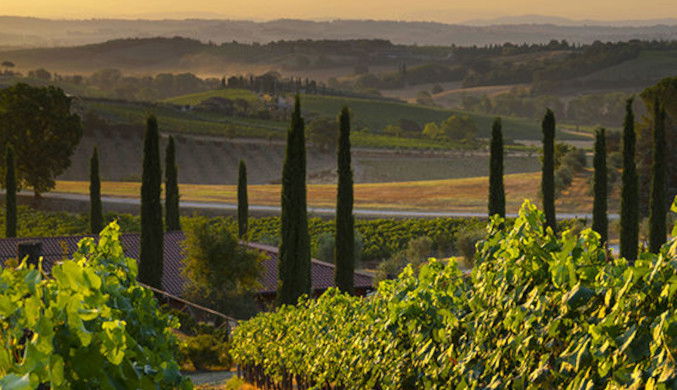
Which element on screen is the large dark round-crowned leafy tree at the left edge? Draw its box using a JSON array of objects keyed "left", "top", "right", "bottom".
[{"left": 0, "top": 83, "right": 82, "bottom": 196}]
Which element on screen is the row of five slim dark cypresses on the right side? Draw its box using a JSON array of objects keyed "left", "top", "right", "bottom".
[{"left": 488, "top": 98, "right": 668, "bottom": 261}]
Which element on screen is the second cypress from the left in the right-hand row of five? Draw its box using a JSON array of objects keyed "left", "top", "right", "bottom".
[{"left": 541, "top": 109, "right": 557, "bottom": 232}]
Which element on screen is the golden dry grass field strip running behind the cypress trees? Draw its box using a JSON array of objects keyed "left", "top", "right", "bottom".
[{"left": 54, "top": 173, "right": 614, "bottom": 213}]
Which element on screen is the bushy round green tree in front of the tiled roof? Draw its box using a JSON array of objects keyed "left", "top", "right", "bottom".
[{"left": 182, "top": 217, "right": 265, "bottom": 312}]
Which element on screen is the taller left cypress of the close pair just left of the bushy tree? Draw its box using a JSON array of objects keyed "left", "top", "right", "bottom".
[{"left": 139, "top": 115, "right": 164, "bottom": 288}]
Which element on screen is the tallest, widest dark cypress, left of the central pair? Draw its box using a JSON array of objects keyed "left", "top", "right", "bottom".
[{"left": 277, "top": 95, "right": 311, "bottom": 304}]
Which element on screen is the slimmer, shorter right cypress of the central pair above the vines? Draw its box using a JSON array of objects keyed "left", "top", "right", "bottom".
[{"left": 334, "top": 107, "right": 355, "bottom": 294}]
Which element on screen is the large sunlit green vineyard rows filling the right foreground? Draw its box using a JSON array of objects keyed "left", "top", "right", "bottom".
[{"left": 231, "top": 202, "right": 677, "bottom": 389}]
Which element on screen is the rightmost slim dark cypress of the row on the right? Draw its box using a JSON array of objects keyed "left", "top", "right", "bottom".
[{"left": 649, "top": 99, "right": 667, "bottom": 253}]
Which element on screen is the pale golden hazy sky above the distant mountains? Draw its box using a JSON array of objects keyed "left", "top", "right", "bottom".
[{"left": 0, "top": 0, "right": 677, "bottom": 22}]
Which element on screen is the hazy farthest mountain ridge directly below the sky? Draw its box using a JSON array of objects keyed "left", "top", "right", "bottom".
[{"left": 0, "top": 16, "right": 677, "bottom": 47}]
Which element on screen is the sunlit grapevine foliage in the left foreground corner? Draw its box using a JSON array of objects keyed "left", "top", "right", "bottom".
[{"left": 0, "top": 224, "right": 191, "bottom": 390}]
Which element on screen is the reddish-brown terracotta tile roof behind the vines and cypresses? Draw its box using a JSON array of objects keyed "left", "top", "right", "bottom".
[{"left": 0, "top": 232, "right": 373, "bottom": 296}]
